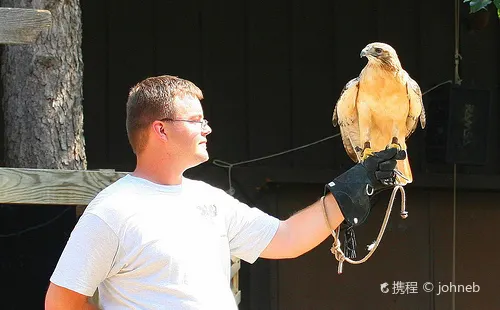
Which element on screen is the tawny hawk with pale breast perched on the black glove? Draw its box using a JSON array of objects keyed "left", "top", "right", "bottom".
[{"left": 332, "top": 42, "right": 425, "bottom": 185}]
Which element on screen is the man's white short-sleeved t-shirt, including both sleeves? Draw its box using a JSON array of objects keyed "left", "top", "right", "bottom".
[{"left": 50, "top": 175, "right": 279, "bottom": 310}]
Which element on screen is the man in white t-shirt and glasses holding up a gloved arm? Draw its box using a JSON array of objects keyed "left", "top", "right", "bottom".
[{"left": 45, "top": 76, "right": 397, "bottom": 309}]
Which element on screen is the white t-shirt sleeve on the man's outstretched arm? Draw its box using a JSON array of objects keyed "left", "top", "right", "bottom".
[{"left": 224, "top": 193, "right": 280, "bottom": 263}]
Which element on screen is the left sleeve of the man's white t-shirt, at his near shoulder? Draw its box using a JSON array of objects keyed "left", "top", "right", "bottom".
[{"left": 50, "top": 213, "right": 118, "bottom": 296}]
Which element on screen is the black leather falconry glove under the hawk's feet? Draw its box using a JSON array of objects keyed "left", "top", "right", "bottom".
[{"left": 326, "top": 148, "right": 406, "bottom": 257}]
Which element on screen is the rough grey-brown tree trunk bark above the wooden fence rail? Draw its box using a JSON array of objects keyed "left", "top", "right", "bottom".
[{"left": 2, "top": 0, "right": 87, "bottom": 169}]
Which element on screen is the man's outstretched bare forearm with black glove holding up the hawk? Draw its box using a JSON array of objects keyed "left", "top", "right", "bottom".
[{"left": 260, "top": 148, "right": 406, "bottom": 259}]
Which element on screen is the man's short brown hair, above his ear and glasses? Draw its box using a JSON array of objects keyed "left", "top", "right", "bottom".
[{"left": 127, "top": 75, "right": 203, "bottom": 154}]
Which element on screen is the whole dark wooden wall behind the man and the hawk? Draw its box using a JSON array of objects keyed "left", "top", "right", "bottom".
[{"left": 82, "top": 0, "right": 500, "bottom": 310}]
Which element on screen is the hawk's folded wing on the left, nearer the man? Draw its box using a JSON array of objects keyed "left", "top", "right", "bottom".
[{"left": 332, "top": 78, "right": 361, "bottom": 162}]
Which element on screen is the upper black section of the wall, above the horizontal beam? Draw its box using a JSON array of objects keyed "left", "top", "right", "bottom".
[{"left": 76, "top": 0, "right": 499, "bottom": 177}]
